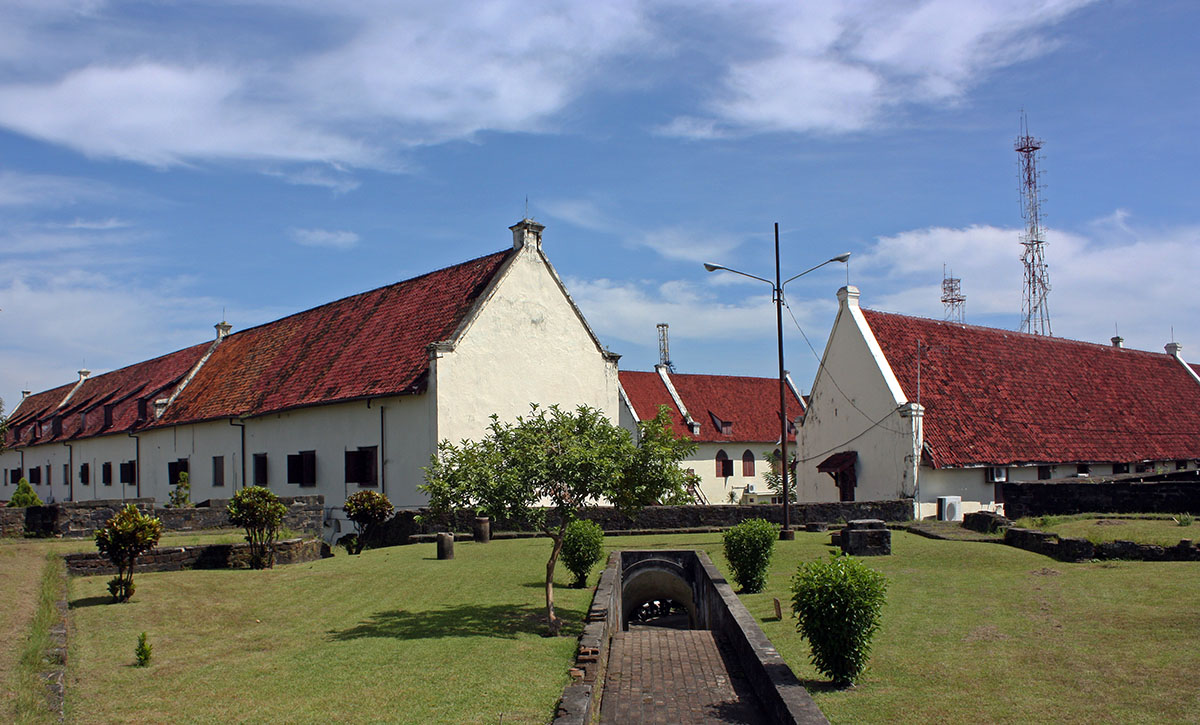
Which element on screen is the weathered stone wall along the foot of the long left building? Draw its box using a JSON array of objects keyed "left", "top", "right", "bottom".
[{"left": 0, "top": 496, "right": 325, "bottom": 538}]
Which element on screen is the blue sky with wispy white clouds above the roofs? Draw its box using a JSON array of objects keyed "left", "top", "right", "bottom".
[{"left": 0, "top": 0, "right": 1200, "bottom": 411}]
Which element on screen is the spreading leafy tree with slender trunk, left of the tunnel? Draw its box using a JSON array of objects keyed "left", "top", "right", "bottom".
[{"left": 421, "top": 405, "right": 695, "bottom": 635}]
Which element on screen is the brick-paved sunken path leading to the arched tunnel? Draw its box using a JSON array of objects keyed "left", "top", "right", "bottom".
[{"left": 600, "top": 627, "right": 767, "bottom": 725}]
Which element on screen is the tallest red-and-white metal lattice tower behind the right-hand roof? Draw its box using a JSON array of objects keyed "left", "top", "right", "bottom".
[{"left": 1013, "top": 113, "right": 1054, "bottom": 335}]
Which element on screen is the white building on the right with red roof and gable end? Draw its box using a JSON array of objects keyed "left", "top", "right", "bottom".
[{"left": 797, "top": 287, "right": 1200, "bottom": 517}]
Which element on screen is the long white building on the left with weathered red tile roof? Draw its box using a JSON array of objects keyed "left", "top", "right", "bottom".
[{"left": 0, "top": 220, "right": 618, "bottom": 535}]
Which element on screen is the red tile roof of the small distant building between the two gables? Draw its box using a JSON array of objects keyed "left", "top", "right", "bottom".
[{"left": 619, "top": 370, "right": 803, "bottom": 443}]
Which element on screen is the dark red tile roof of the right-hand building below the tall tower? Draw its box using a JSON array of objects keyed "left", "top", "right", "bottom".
[{"left": 863, "top": 310, "right": 1200, "bottom": 468}]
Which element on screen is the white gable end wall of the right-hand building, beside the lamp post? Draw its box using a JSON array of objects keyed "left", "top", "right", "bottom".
[{"left": 797, "top": 287, "right": 922, "bottom": 502}]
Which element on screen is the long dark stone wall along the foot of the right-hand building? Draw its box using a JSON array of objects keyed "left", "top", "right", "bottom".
[{"left": 1003, "top": 479, "right": 1200, "bottom": 519}]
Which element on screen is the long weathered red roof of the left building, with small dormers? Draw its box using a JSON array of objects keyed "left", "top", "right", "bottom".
[{"left": 10, "top": 250, "right": 512, "bottom": 445}]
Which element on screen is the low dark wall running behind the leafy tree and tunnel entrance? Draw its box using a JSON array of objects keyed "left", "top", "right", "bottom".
[{"left": 372, "top": 498, "right": 912, "bottom": 546}]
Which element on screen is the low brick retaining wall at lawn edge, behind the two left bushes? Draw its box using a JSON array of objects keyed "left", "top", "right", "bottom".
[{"left": 62, "top": 539, "right": 332, "bottom": 576}]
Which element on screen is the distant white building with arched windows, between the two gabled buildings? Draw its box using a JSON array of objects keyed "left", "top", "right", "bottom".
[{"left": 620, "top": 365, "right": 804, "bottom": 504}]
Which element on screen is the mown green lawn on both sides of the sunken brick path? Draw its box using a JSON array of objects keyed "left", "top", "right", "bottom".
[{"left": 16, "top": 532, "right": 1200, "bottom": 723}]
